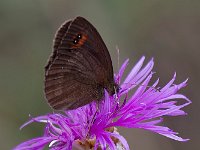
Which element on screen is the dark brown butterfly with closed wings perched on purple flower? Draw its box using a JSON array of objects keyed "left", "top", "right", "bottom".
[{"left": 45, "top": 17, "right": 118, "bottom": 110}]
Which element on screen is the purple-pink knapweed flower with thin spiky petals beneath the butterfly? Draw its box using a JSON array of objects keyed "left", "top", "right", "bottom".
[{"left": 14, "top": 57, "right": 191, "bottom": 150}]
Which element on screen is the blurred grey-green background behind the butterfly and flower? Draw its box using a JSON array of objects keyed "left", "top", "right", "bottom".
[{"left": 0, "top": 0, "right": 200, "bottom": 150}]
